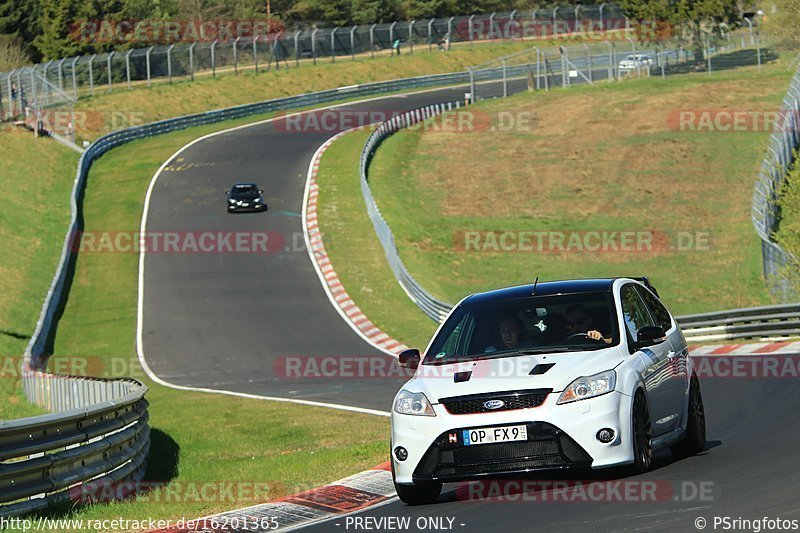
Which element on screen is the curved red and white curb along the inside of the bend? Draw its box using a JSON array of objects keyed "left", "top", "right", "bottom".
[{"left": 303, "top": 128, "right": 408, "bottom": 355}]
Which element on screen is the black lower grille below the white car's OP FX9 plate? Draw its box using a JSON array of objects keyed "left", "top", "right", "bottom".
[{"left": 414, "top": 422, "right": 592, "bottom": 481}]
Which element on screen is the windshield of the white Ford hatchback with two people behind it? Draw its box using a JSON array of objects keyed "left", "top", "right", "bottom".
[{"left": 424, "top": 291, "right": 619, "bottom": 365}]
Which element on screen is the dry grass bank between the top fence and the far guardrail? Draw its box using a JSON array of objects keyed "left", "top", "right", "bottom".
[{"left": 75, "top": 41, "right": 540, "bottom": 139}]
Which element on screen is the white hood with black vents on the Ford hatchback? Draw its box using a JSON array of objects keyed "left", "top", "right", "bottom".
[{"left": 404, "top": 346, "right": 627, "bottom": 403}]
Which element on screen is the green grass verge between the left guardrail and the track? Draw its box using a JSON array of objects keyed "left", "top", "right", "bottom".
[{"left": 7, "top": 117, "right": 387, "bottom": 519}]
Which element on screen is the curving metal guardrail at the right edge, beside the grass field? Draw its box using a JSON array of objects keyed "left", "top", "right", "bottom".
[{"left": 752, "top": 61, "right": 800, "bottom": 300}]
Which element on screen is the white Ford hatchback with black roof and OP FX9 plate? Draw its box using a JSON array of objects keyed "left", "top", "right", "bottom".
[{"left": 391, "top": 278, "right": 705, "bottom": 504}]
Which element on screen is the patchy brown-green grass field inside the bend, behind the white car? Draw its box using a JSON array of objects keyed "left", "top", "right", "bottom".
[{"left": 310, "top": 61, "right": 791, "bottom": 346}]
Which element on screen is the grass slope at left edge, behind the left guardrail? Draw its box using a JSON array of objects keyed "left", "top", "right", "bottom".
[{"left": 0, "top": 127, "right": 78, "bottom": 419}]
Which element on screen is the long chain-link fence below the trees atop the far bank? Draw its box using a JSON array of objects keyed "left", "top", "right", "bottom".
[{"left": 0, "top": 3, "right": 648, "bottom": 119}]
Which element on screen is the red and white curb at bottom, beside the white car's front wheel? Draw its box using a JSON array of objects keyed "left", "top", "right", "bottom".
[{"left": 150, "top": 461, "right": 395, "bottom": 533}]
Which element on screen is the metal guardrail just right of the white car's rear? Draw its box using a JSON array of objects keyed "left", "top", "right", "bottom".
[{"left": 676, "top": 303, "right": 800, "bottom": 342}]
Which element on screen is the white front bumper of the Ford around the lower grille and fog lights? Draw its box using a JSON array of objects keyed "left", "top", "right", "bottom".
[{"left": 391, "top": 391, "right": 633, "bottom": 483}]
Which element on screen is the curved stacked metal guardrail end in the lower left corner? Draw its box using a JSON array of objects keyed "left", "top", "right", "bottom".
[{"left": 0, "top": 370, "right": 150, "bottom": 517}]
